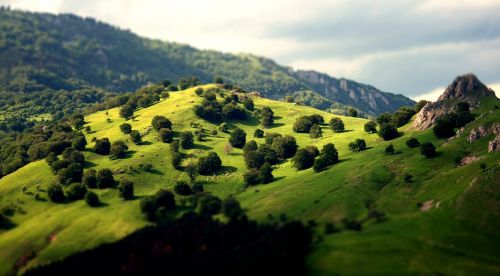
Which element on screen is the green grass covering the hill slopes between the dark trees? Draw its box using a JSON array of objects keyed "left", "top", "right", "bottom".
[{"left": 0, "top": 85, "right": 500, "bottom": 275}]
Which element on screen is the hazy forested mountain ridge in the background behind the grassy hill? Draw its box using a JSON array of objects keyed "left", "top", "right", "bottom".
[{"left": 0, "top": 8, "right": 414, "bottom": 114}]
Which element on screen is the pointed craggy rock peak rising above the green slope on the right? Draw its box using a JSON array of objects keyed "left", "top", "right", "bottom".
[{"left": 413, "top": 74, "right": 496, "bottom": 130}]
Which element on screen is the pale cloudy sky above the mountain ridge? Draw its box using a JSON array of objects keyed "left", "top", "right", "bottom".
[{"left": 0, "top": 0, "right": 500, "bottom": 100}]
